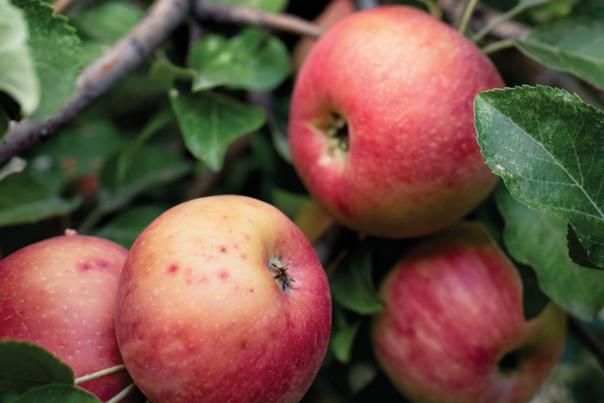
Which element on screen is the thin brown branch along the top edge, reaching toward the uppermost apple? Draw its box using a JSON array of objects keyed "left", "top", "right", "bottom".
[{"left": 193, "top": 0, "right": 323, "bottom": 38}]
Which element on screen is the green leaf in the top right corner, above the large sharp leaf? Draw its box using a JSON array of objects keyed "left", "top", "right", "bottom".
[{"left": 518, "top": 0, "right": 604, "bottom": 89}]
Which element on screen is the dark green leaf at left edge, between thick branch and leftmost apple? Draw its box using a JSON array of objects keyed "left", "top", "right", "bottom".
[{"left": 0, "top": 171, "right": 80, "bottom": 226}]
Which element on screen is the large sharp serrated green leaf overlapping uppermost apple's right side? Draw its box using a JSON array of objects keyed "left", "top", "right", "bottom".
[{"left": 474, "top": 86, "right": 604, "bottom": 267}]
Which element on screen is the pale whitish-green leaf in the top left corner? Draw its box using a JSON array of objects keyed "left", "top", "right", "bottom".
[{"left": 0, "top": 0, "right": 40, "bottom": 118}]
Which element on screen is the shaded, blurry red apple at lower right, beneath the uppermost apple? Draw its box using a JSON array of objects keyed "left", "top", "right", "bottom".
[{"left": 372, "top": 223, "right": 566, "bottom": 403}]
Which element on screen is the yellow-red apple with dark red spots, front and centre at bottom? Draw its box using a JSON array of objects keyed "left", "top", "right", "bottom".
[{"left": 116, "top": 196, "right": 331, "bottom": 403}]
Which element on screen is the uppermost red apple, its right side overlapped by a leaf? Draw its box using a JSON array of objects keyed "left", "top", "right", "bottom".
[{"left": 289, "top": 6, "right": 503, "bottom": 238}]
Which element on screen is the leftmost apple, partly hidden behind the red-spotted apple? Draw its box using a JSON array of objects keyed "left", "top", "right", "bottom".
[{"left": 0, "top": 234, "right": 132, "bottom": 401}]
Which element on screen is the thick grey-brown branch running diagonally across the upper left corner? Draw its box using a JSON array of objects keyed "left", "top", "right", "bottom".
[{"left": 0, "top": 0, "right": 189, "bottom": 164}]
